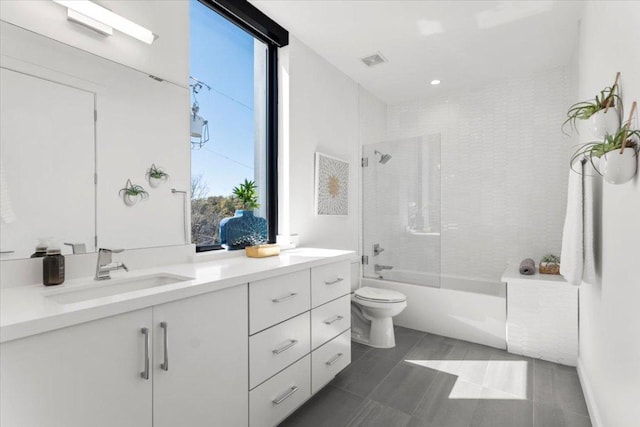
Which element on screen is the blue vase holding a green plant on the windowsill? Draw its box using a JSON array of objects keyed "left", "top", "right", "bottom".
[{"left": 220, "top": 179, "right": 267, "bottom": 250}]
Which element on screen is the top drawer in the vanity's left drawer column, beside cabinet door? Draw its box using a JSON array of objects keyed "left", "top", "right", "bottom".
[{"left": 249, "top": 269, "right": 311, "bottom": 335}]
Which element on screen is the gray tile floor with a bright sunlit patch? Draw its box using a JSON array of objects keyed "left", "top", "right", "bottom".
[{"left": 280, "top": 327, "right": 591, "bottom": 427}]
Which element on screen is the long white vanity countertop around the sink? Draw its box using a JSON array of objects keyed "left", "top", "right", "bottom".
[{"left": 0, "top": 248, "right": 355, "bottom": 342}]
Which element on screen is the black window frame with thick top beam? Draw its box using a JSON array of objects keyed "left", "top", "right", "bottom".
[{"left": 198, "top": 0, "right": 289, "bottom": 243}]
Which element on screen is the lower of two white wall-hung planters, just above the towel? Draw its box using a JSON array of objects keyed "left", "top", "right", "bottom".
[{"left": 571, "top": 102, "right": 640, "bottom": 184}]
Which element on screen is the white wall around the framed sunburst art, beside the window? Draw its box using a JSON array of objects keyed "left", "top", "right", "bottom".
[{"left": 279, "top": 37, "right": 384, "bottom": 251}]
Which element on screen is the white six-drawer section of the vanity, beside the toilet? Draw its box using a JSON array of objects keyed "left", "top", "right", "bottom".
[{"left": 249, "top": 261, "right": 351, "bottom": 427}]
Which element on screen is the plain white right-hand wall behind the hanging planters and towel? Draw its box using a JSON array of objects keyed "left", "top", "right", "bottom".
[{"left": 578, "top": 1, "right": 640, "bottom": 427}]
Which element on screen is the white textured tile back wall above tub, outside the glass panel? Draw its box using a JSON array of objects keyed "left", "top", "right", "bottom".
[{"left": 387, "top": 67, "right": 577, "bottom": 282}]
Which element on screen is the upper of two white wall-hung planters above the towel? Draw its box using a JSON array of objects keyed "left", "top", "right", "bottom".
[{"left": 562, "top": 73, "right": 620, "bottom": 139}]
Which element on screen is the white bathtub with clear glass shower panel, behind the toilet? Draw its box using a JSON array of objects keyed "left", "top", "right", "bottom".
[{"left": 360, "top": 134, "right": 506, "bottom": 348}]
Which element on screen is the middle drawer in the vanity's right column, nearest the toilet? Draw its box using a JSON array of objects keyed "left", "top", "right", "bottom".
[{"left": 311, "top": 295, "right": 351, "bottom": 349}]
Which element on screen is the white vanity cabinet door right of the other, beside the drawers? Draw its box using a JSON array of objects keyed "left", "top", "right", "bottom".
[{"left": 153, "top": 285, "right": 249, "bottom": 427}]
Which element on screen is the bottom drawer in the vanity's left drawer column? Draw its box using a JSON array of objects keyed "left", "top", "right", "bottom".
[{"left": 249, "top": 355, "right": 311, "bottom": 427}]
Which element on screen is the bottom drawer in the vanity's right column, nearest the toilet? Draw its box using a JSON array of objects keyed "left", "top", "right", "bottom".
[{"left": 311, "top": 330, "right": 351, "bottom": 394}]
